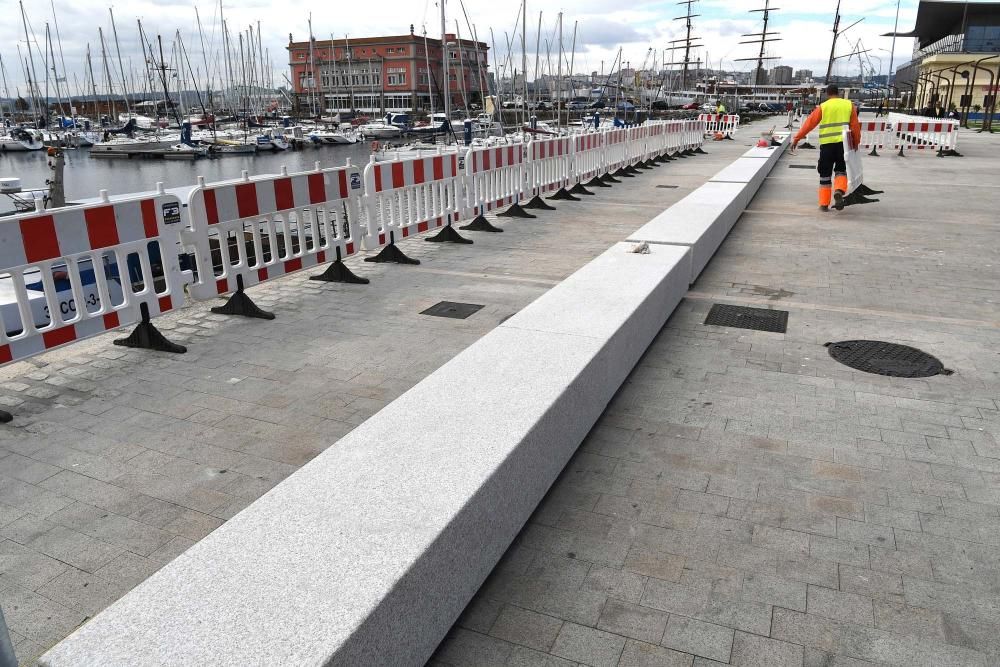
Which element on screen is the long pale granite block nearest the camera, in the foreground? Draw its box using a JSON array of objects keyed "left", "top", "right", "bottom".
[{"left": 41, "top": 243, "right": 696, "bottom": 667}]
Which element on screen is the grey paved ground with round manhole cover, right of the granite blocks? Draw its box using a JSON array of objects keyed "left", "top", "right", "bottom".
[{"left": 431, "top": 122, "right": 1000, "bottom": 667}]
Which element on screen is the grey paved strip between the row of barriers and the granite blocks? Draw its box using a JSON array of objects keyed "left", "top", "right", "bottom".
[{"left": 0, "top": 128, "right": 764, "bottom": 664}]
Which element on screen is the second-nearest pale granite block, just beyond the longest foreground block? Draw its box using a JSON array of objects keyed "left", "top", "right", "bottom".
[{"left": 628, "top": 183, "right": 749, "bottom": 283}]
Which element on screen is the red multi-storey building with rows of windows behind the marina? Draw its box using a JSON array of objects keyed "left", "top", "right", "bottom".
[{"left": 288, "top": 32, "right": 491, "bottom": 115}]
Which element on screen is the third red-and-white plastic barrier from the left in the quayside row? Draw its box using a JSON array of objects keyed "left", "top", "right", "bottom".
[{"left": 364, "top": 153, "right": 464, "bottom": 245}]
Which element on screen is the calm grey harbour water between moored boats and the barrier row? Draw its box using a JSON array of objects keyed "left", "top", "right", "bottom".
[{"left": 0, "top": 142, "right": 371, "bottom": 211}]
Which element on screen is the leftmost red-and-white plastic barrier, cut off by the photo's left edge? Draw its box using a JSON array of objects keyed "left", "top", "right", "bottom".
[{"left": 0, "top": 189, "right": 185, "bottom": 364}]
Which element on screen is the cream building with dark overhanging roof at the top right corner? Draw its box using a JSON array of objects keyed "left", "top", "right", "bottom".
[{"left": 895, "top": 0, "right": 1000, "bottom": 117}]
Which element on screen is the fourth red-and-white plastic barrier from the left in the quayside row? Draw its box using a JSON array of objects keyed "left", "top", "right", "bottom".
[{"left": 464, "top": 144, "right": 525, "bottom": 217}]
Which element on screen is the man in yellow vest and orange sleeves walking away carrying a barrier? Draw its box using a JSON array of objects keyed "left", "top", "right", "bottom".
[{"left": 792, "top": 84, "right": 861, "bottom": 211}]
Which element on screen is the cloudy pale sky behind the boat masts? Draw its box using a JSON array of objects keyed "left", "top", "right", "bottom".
[{"left": 0, "top": 0, "right": 917, "bottom": 95}]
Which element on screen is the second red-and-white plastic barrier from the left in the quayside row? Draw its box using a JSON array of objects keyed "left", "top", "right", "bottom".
[{"left": 182, "top": 163, "right": 361, "bottom": 299}]
